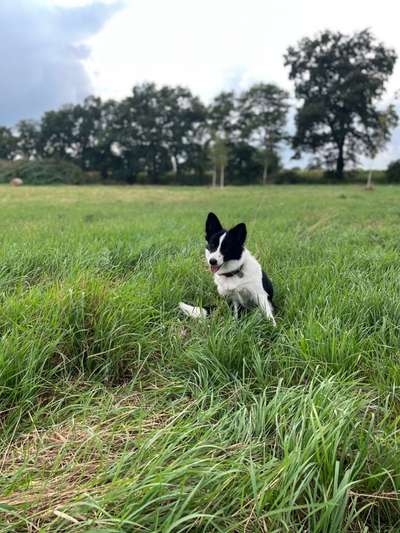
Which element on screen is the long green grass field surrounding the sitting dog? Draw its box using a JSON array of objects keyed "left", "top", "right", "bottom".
[{"left": 0, "top": 186, "right": 400, "bottom": 533}]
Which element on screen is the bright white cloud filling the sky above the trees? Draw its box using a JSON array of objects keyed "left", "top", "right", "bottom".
[{"left": 88, "top": 0, "right": 400, "bottom": 98}]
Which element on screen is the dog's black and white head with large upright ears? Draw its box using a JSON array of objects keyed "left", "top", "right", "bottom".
[{"left": 206, "top": 213, "right": 247, "bottom": 274}]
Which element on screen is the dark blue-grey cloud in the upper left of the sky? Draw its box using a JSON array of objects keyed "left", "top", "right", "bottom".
[{"left": 0, "top": 0, "right": 122, "bottom": 125}]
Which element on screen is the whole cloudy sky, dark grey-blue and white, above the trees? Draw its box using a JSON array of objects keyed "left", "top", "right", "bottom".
[{"left": 0, "top": 0, "right": 400, "bottom": 168}]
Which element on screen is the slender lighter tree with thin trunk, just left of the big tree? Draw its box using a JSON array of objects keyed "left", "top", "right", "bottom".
[{"left": 239, "top": 83, "right": 289, "bottom": 184}]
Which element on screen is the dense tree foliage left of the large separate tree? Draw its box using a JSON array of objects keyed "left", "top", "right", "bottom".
[{"left": 1, "top": 83, "right": 287, "bottom": 185}]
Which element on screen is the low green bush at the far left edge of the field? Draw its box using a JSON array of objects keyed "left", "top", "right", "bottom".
[{"left": 0, "top": 159, "right": 86, "bottom": 185}]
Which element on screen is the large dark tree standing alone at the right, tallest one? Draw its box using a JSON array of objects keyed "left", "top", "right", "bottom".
[{"left": 285, "top": 30, "right": 397, "bottom": 178}]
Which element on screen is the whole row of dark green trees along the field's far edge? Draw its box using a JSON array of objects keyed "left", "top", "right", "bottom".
[{"left": 0, "top": 30, "right": 398, "bottom": 186}]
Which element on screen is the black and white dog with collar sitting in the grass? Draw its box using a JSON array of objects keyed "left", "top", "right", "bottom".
[{"left": 179, "top": 213, "right": 276, "bottom": 326}]
